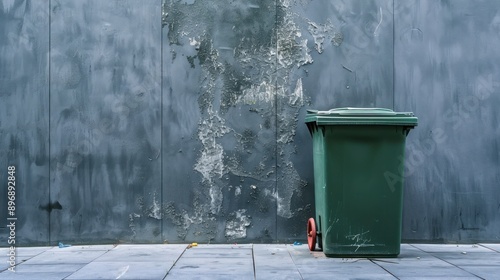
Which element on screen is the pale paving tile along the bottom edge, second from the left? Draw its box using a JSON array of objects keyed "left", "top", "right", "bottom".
[{"left": 65, "top": 261, "right": 171, "bottom": 280}]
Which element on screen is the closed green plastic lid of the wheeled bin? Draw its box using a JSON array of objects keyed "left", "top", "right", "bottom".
[{"left": 306, "top": 107, "right": 418, "bottom": 126}]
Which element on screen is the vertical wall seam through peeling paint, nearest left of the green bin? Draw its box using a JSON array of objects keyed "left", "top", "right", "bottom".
[{"left": 274, "top": 0, "right": 279, "bottom": 241}]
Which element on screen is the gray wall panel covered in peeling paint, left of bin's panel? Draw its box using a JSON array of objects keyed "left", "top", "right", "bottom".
[{"left": 163, "top": 0, "right": 276, "bottom": 242}]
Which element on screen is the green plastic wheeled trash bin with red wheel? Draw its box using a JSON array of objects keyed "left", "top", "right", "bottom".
[{"left": 305, "top": 108, "right": 418, "bottom": 257}]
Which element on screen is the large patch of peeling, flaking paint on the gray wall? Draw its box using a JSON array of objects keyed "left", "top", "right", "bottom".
[{"left": 163, "top": 1, "right": 313, "bottom": 241}]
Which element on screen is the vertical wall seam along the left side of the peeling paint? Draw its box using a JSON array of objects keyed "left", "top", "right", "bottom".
[{"left": 159, "top": 0, "right": 165, "bottom": 243}]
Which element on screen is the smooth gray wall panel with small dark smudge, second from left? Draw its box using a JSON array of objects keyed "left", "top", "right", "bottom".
[{"left": 50, "top": 1, "right": 161, "bottom": 242}]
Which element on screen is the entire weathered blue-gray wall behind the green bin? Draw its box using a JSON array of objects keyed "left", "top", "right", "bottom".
[{"left": 0, "top": 0, "right": 500, "bottom": 246}]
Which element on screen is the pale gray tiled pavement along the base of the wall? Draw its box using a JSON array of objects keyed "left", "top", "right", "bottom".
[{"left": 0, "top": 244, "right": 500, "bottom": 280}]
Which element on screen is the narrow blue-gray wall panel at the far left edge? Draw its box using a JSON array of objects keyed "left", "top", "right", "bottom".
[{"left": 0, "top": 1, "right": 49, "bottom": 246}]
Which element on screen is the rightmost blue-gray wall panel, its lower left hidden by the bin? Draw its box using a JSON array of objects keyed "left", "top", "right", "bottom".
[{"left": 395, "top": 0, "right": 500, "bottom": 242}]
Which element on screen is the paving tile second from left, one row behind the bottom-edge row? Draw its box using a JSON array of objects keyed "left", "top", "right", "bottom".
[{"left": 24, "top": 251, "right": 106, "bottom": 264}]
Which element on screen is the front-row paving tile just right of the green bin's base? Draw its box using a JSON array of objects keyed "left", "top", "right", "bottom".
[{"left": 375, "top": 259, "right": 474, "bottom": 278}]
